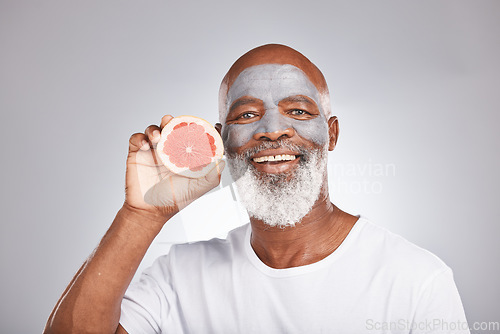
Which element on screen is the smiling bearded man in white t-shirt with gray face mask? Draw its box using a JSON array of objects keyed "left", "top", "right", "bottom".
[{"left": 46, "top": 45, "right": 468, "bottom": 333}]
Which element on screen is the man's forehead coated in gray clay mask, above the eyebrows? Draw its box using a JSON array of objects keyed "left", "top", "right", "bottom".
[{"left": 227, "top": 64, "right": 319, "bottom": 107}]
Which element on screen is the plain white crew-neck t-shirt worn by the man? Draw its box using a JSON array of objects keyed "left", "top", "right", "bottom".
[{"left": 120, "top": 218, "right": 469, "bottom": 334}]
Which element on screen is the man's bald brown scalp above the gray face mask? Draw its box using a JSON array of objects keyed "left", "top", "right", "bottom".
[{"left": 219, "top": 44, "right": 330, "bottom": 124}]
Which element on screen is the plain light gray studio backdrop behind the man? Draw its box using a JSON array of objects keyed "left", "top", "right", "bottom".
[{"left": 0, "top": 0, "right": 500, "bottom": 333}]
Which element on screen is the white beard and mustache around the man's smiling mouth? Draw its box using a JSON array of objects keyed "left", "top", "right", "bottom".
[{"left": 227, "top": 142, "right": 328, "bottom": 227}]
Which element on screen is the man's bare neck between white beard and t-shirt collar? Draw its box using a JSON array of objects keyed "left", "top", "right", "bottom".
[{"left": 250, "top": 187, "right": 358, "bottom": 269}]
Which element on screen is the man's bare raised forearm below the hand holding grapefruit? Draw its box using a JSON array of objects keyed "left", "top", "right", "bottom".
[{"left": 45, "top": 207, "right": 168, "bottom": 333}]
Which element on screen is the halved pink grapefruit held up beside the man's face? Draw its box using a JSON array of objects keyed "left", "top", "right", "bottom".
[{"left": 156, "top": 116, "right": 224, "bottom": 178}]
